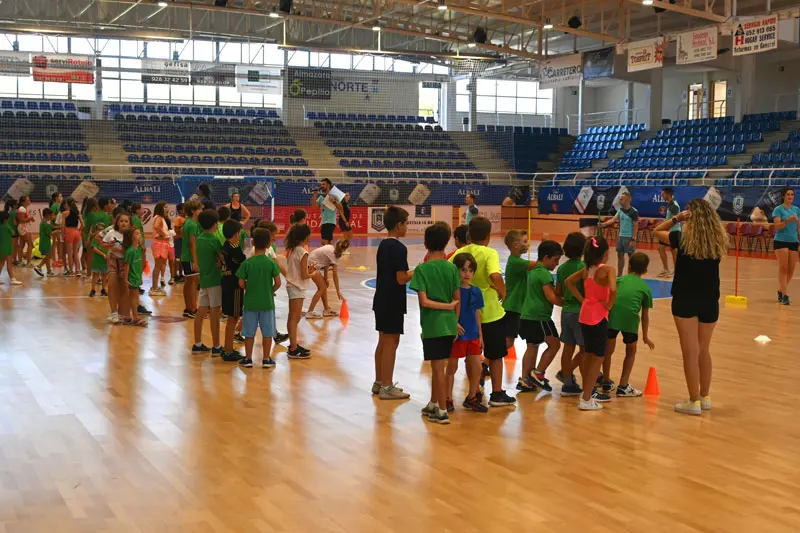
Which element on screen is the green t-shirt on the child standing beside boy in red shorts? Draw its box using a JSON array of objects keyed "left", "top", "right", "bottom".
[{"left": 411, "top": 259, "right": 461, "bottom": 339}]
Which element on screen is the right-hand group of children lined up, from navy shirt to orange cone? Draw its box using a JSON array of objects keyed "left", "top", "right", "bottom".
[{"left": 372, "top": 206, "right": 654, "bottom": 424}]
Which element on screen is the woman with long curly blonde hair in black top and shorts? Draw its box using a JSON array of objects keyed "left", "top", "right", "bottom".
[{"left": 656, "top": 198, "right": 728, "bottom": 416}]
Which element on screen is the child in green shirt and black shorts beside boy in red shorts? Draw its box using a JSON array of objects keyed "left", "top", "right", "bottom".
[{"left": 411, "top": 222, "right": 461, "bottom": 424}]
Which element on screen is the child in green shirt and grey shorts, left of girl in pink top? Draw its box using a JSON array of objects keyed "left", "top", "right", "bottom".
[{"left": 556, "top": 231, "right": 586, "bottom": 396}]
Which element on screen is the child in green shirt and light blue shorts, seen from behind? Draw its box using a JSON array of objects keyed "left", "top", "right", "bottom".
[{"left": 236, "top": 228, "right": 281, "bottom": 368}]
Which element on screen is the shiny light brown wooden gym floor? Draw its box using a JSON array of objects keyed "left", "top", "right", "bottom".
[{"left": 0, "top": 239, "right": 800, "bottom": 533}]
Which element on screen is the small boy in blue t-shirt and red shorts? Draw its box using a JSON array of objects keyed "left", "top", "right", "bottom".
[{"left": 447, "top": 253, "right": 489, "bottom": 413}]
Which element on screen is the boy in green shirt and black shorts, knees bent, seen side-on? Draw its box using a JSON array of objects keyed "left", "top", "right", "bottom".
[{"left": 517, "top": 241, "right": 564, "bottom": 392}]
